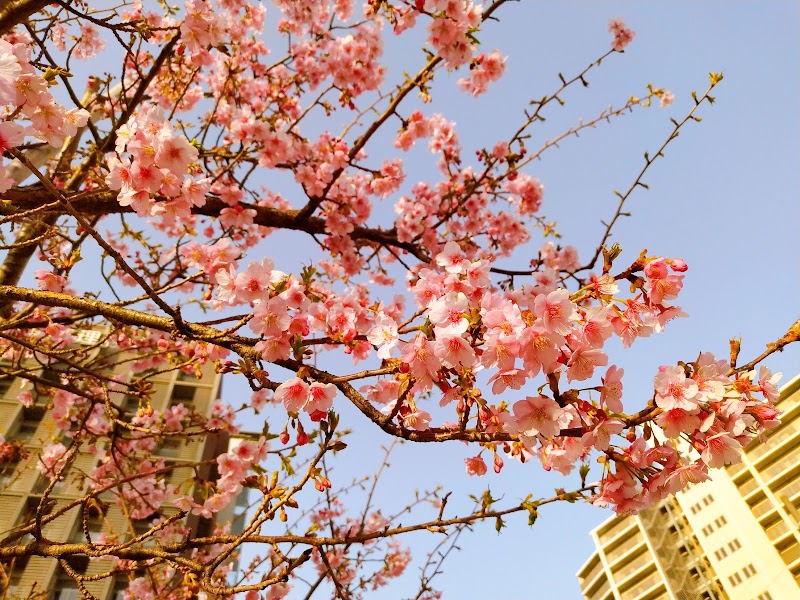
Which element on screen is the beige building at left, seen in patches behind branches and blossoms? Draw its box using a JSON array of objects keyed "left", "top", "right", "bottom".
[{"left": 0, "top": 332, "right": 231, "bottom": 600}]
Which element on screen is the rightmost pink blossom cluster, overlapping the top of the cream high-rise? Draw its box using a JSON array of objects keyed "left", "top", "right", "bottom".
[{"left": 594, "top": 364, "right": 781, "bottom": 513}]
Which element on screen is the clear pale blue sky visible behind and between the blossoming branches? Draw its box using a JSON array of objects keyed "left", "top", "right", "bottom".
[{"left": 219, "top": 1, "right": 800, "bottom": 600}]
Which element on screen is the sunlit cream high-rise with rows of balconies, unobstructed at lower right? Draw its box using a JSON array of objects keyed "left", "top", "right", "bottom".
[{"left": 578, "top": 376, "right": 800, "bottom": 600}]
